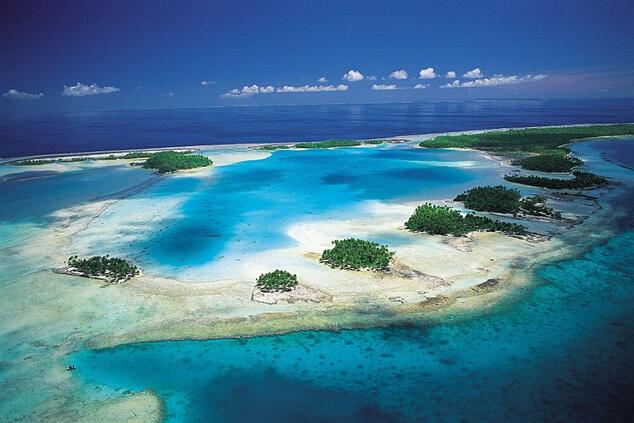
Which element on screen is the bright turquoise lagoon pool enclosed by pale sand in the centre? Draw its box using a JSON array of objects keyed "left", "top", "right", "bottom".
[{"left": 125, "top": 146, "right": 502, "bottom": 275}]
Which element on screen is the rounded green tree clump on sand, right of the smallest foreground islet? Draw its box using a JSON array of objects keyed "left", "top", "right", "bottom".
[{"left": 319, "top": 238, "right": 394, "bottom": 270}]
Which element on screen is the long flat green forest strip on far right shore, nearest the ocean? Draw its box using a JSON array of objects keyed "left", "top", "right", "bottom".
[{"left": 420, "top": 124, "right": 634, "bottom": 155}]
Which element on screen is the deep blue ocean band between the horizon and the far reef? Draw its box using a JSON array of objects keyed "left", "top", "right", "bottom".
[{"left": 0, "top": 99, "right": 634, "bottom": 157}]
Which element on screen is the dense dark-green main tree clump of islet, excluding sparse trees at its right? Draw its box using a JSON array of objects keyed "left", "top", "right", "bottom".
[{"left": 454, "top": 185, "right": 522, "bottom": 213}]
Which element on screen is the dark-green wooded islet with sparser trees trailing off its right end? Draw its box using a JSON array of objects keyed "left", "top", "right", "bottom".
[{"left": 454, "top": 185, "right": 561, "bottom": 218}]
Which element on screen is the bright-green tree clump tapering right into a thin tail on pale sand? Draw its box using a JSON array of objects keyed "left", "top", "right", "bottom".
[{"left": 405, "top": 203, "right": 526, "bottom": 236}]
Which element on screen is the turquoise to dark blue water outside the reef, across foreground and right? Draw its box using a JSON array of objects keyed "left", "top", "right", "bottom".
[{"left": 71, "top": 142, "right": 634, "bottom": 422}]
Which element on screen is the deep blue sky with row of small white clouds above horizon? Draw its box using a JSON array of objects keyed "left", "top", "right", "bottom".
[{"left": 0, "top": 0, "right": 634, "bottom": 112}]
